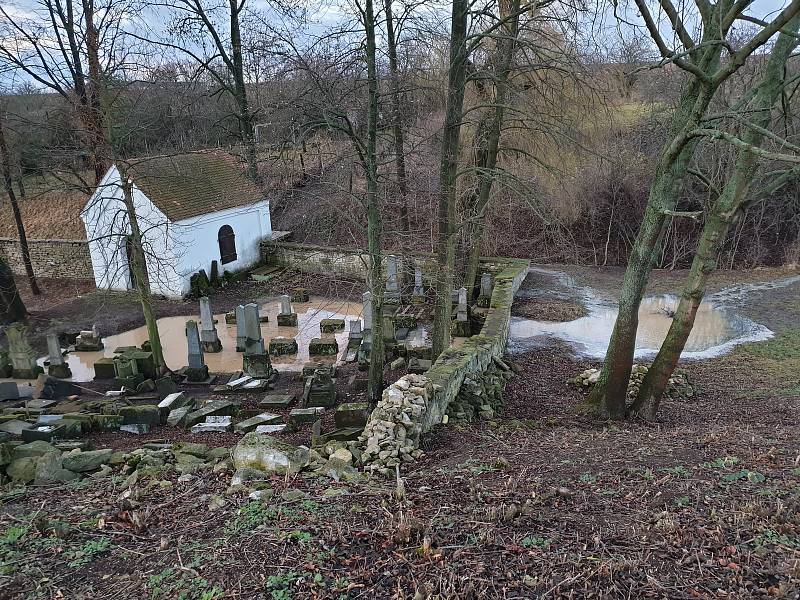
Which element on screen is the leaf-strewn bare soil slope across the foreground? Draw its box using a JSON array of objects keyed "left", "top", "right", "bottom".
[{"left": 0, "top": 266, "right": 800, "bottom": 600}]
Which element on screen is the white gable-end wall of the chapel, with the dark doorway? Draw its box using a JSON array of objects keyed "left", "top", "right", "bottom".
[{"left": 81, "top": 166, "right": 182, "bottom": 296}]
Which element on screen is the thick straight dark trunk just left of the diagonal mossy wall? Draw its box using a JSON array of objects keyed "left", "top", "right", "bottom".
[{"left": 432, "top": 0, "right": 469, "bottom": 360}]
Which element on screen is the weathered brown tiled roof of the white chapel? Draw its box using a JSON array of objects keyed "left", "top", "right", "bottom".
[{"left": 126, "top": 150, "right": 264, "bottom": 222}]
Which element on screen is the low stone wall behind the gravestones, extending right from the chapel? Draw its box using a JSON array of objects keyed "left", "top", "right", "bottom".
[{"left": 261, "top": 239, "right": 509, "bottom": 287}]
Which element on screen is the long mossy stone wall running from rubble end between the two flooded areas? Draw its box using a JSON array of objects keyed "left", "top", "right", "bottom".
[{"left": 360, "top": 260, "right": 530, "bottom": 473}]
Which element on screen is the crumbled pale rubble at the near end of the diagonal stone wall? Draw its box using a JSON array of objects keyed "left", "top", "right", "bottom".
[{"left": 359, "top": 374, "right": 428, "bottom": 474}]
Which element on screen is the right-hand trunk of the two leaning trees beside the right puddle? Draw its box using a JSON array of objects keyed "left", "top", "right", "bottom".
[{"left": 631, "top": 17, "right": 800, "bottom": 420}]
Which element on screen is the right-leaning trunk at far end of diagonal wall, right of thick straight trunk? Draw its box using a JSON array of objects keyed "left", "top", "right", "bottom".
[{"left": 464, "top": 0, "right": 520, "bottom": 295}]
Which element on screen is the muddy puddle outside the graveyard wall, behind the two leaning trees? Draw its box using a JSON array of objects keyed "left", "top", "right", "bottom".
[{"left": 509, "top": 269, "right": 773, "bottom": 359}]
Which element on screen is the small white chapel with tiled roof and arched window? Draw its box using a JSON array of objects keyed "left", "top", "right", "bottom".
[{"left": 81, "top": 151, "right": 272, "bottom": 297}]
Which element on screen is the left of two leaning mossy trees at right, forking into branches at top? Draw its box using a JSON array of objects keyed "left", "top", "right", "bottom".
[{"left": 585, "top": 0, "right": 800, "bottom": 419}]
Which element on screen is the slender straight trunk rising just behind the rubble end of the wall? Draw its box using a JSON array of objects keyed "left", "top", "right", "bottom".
[{"left": 364, "top": 0, "right": 384, "bottom": 403}]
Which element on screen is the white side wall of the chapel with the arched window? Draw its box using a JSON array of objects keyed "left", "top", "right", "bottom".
[{"left": 171, "top": 200, "right": 272, "bottom": 294}]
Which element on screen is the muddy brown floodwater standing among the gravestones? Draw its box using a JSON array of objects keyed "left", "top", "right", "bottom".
[{"left": 40, "top": 297, "right": 362, "bottom": 381}]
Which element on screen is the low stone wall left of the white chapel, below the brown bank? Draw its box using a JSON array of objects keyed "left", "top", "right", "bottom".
[{"left": 0, "top": 238, "right": 94, "bottom": 279}]
